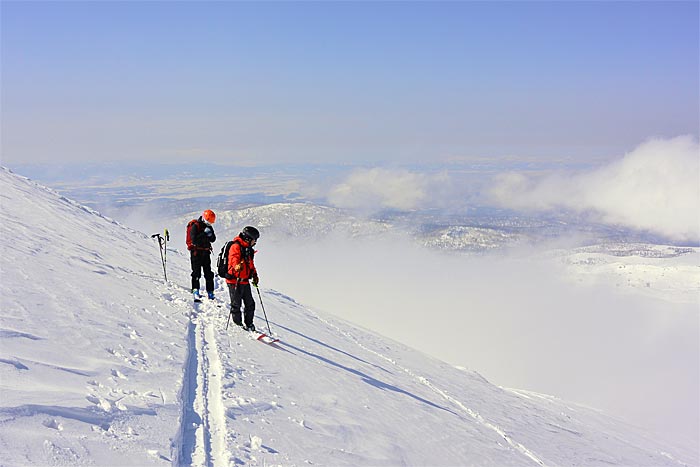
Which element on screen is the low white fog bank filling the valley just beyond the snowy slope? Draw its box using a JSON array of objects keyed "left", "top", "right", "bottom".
[{"left": 256, "top": 234, "right": 700, "bottom": 446}]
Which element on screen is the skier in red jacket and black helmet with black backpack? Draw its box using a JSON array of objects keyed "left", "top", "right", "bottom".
[{"left": 226, "top": 226, "right": 260, "bottom": 331}]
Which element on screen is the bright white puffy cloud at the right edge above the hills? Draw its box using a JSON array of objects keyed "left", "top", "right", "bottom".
[{"left": 490, "top": 136, "right": 700, "bottom": 241}]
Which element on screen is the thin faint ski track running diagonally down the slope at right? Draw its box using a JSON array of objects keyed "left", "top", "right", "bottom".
[{"left": 306, "top": 309, "right": 545, "bottom": 466}]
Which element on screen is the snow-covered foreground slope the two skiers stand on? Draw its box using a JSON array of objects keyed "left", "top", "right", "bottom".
[{"left": 0, "top": 170, "right": 698, "bottom": 466}]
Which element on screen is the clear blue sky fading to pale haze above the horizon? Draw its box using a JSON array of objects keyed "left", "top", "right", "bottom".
[{"left": 1, "top": 1, "right": 700, "bottom": 167}]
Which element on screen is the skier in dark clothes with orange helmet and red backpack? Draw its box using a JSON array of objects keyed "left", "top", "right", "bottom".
[{"left": 187, "top": 209, "right": 216, "bottom": 300}]
